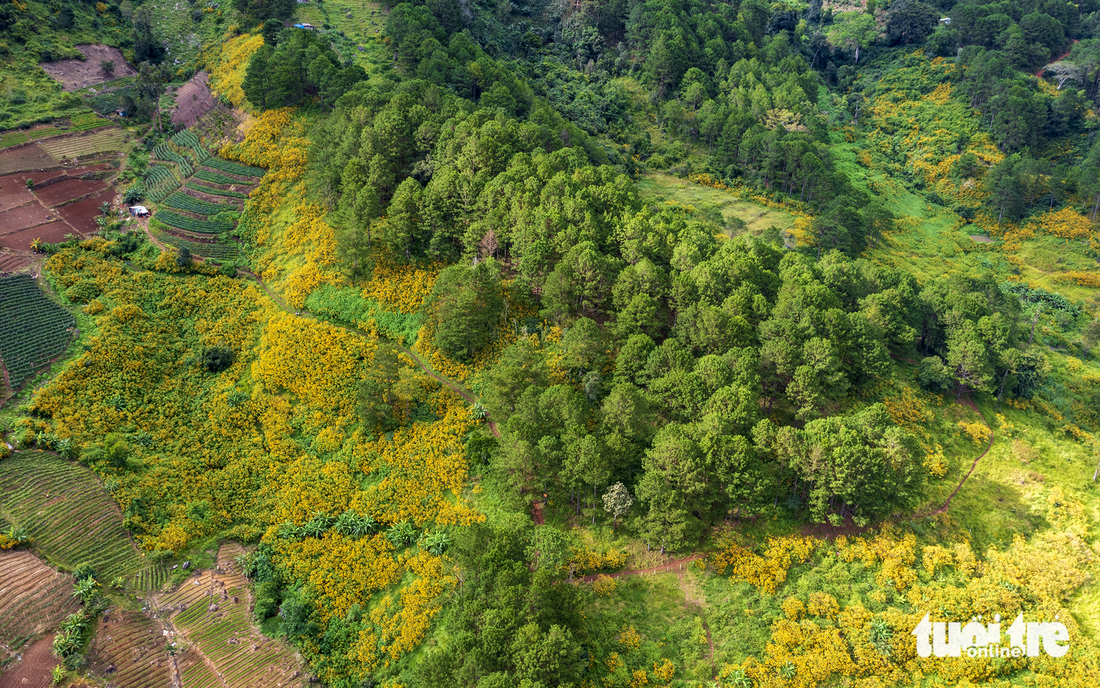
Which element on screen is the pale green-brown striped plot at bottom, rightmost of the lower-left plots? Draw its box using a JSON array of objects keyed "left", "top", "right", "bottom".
[{"left": 157, "top": 543, "right": 305, "bottom": 688}]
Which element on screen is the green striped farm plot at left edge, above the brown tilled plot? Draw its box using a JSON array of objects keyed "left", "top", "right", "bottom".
[{"left": 0, "top": 451, "right": 145, "bottom": 580}]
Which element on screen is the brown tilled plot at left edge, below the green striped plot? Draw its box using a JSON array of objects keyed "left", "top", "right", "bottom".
[{"left": 0, "top": 549, "right": 80, "bottom": 652}]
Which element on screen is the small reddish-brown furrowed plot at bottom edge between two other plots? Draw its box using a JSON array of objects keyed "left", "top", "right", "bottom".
[{"left": 88, "top": 609, "right": 172, "bottom": 688}]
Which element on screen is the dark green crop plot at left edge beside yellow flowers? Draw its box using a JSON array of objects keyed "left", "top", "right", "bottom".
[{"left": 0, "top": 275, "right": 76, "bottom": 389}]
